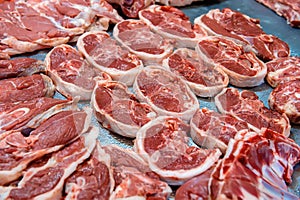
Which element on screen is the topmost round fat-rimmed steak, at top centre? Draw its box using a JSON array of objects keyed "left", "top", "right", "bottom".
[{"left": 139, "top": 5, "right": 207, "bottom": 48}]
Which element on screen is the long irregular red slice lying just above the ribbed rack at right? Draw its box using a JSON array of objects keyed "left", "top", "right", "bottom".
[{"left": 215, "top": 88, "right": 291, "bottom": 137}]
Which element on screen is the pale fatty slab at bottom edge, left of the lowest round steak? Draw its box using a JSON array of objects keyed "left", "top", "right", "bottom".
[{"left": 103, "top": 145, "right": 172, "bottom": 200}]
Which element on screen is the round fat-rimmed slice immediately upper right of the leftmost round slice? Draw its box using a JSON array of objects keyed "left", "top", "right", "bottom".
[{"left": 77, "top": 31, "right": 143, "bottom": 86}]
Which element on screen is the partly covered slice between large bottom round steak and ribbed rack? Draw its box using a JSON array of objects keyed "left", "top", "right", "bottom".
[{"left": 190, "top": 108, "right": 248, "bottom": 153}]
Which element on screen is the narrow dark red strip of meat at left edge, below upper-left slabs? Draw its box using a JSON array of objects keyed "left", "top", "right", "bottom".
[{"left": 0, "top": 58, "right": 46, "bottom": 79}]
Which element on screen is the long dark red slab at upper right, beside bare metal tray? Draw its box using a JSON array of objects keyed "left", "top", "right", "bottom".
[{"left": 194, "top": 8, "right": 290, "bottom": 61}]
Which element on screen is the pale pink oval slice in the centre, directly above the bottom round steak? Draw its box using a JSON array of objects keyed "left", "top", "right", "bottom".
[{"left": 133, "top": 66, "right": 199, "bottom": 121}]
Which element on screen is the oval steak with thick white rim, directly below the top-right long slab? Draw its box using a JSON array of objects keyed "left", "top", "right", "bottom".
[{"left": 196, "top": 36, "right": 267, "bottom": 87}]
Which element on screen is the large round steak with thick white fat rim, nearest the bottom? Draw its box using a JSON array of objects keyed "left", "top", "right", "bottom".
[{"left": 134, "top": 116, "right": 221, "bottom": 185}]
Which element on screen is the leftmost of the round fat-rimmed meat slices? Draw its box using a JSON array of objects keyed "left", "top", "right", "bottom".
[{"left": 45, "top": 44, "right": 111, "bottom": 100}]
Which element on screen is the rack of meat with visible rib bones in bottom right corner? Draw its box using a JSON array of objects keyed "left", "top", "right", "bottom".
[{"left": 209, "top": 130, "right": 300, "bottom": 200}]
